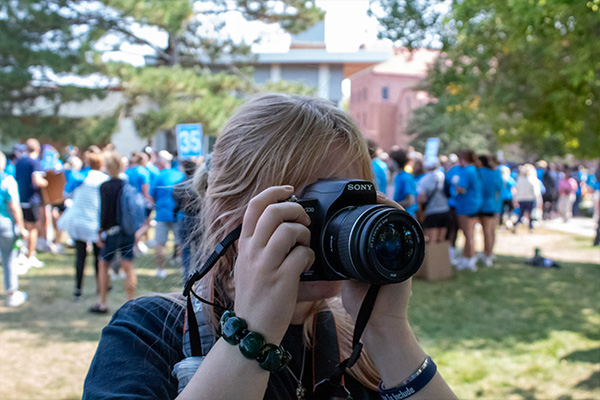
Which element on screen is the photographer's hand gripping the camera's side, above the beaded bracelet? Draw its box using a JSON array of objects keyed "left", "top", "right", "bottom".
[{"left": 234, "top": 186, "right": 315, "bottom": 344}]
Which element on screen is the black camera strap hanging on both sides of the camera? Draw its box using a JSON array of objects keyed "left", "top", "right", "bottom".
[{"left": 183, "top": 224, "right": 381, "bottom": 399}]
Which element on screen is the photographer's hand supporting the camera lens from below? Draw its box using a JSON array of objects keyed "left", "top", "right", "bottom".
[{"left": 342, "top": 192, "right": 411, "bottom": 333}]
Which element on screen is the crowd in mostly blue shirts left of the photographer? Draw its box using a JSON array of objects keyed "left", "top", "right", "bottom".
[{"left": 0, "top": 138, "right": 202, "bottom": 313}]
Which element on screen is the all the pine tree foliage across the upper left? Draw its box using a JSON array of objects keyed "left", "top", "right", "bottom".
[{"left": 0, "top": 0, "right": 323, "bottom": 146}]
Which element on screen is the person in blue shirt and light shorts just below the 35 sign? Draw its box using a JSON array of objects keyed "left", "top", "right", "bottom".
[{"left": 150, "top": 150, "right": 185, "bottom": 278}]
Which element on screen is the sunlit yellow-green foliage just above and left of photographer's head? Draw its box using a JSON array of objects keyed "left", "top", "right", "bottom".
[{"left": 113, "top": 64, "right": 315, "bottom": 142}]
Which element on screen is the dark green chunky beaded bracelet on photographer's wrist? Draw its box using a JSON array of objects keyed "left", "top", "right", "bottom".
[{"left": 221, "top": 310, "right": 292, "bottom": 372}]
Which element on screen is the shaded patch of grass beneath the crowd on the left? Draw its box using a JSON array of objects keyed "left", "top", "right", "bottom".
[{"left": 0, "top": 254, "right": 181, "bottom": 347}]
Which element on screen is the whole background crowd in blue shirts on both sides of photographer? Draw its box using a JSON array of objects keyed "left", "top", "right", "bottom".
[{"left": 0, "top": 134, "right": 600, "bottom": 313}]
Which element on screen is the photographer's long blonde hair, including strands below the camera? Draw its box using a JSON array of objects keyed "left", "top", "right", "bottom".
[{"left": 193, "top": 94, "right": 379, "bottom": 388}]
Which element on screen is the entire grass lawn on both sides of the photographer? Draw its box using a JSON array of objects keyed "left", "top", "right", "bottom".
[{"left": 0, "top": 229, "right": 600, "bottom": 400}]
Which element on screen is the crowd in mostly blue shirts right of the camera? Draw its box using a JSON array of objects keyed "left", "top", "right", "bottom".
[{"left": 369, "top": 140, "right": 600, "bottom": 271}]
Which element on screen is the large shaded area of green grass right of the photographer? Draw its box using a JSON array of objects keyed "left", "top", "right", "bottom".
[{"left": 409, "top": 256, "right": 600, "bottom": 349}]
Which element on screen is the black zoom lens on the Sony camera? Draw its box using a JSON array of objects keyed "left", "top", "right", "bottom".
[{"left": 322, "top": 204, "right": 425, "bottom": 285}]
